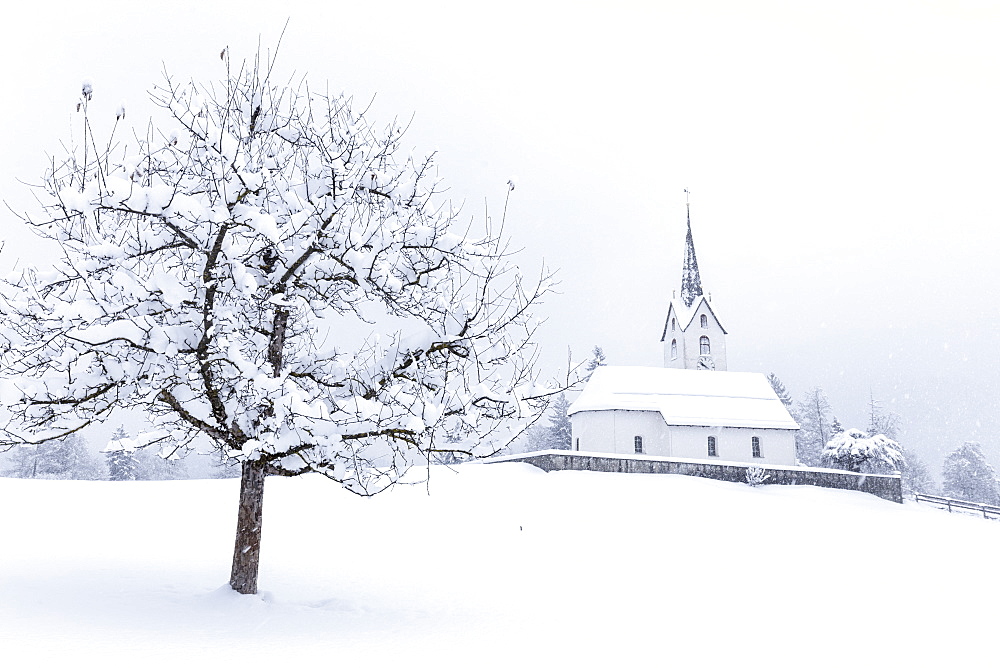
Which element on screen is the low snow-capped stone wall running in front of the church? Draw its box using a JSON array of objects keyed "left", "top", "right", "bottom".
[{"left": 488, "top": 450, "right": 903, "bottom": 503}]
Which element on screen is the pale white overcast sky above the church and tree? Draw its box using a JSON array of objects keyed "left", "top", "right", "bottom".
[{"left": 0, "top": 0, "right": 1000, "bottom": 474}]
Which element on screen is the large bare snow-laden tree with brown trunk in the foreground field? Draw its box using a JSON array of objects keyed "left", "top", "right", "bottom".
[{"left": 0, "top": 47, "right": 553, "bottom": 593}]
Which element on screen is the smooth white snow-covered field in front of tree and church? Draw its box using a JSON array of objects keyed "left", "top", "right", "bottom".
[{"left": 0, "top": 463, "right": 1000, "bottom": 666}]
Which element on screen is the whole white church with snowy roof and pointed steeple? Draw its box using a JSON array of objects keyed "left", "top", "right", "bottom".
[{"left": 569, "top": 204, "right": 799, "bottom": 466}]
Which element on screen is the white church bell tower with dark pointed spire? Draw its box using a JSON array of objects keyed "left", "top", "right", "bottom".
[{"left": 660, "top": 190, "right": 726, "bottom": 371}]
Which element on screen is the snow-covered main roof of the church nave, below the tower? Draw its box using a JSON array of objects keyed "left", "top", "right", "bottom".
[{"left": 569, "top": 366, "right": 799, "bottom": 429}]
